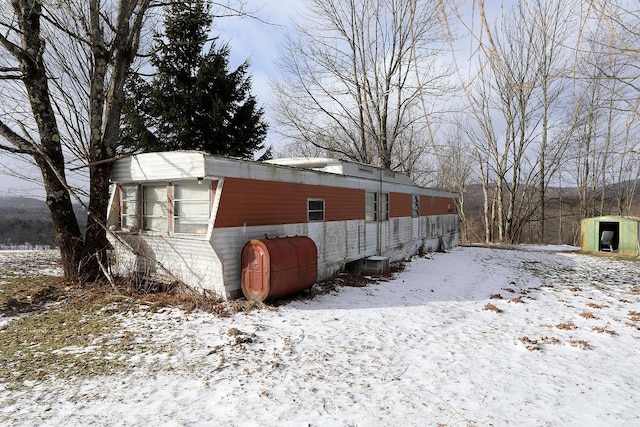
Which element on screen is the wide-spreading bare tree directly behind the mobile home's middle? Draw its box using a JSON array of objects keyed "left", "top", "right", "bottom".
[{"left": 274, "top": 0, "right": 452, "bottom": 172}]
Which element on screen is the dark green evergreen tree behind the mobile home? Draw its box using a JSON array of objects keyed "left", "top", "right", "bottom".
[{"left": 122, "top": 0, "right": 267, "bottom": 157}]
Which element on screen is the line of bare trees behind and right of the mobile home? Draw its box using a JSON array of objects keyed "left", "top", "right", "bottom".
[{"left": 274, "top": 0, "right": 640, "bottom": 244}]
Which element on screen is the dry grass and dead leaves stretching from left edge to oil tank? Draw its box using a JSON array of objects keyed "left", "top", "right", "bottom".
[{"left": 0, "top": 277, "right": 270, "bottom": 388}]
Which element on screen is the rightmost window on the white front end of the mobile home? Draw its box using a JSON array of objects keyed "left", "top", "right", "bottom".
[{"left": 173, "top": 182, "right": 211, "bottom": 234}]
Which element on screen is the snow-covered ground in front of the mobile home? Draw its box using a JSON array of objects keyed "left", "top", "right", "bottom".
[{"left": 0, "top": 247, "right": 640, "bottom": 426}]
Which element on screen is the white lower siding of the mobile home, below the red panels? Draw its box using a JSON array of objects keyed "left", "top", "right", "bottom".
[{"left": 113, "top": 214, "right": 458, "bottom": 298}]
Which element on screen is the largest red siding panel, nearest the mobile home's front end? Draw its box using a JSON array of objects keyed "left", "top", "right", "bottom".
[{"left": 215, "top": 178, "right": 364, "bottom": 227}]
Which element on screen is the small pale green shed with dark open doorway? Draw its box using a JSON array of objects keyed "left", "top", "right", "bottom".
[{"left": 580, "top": 216, "right": 640, "bottom": 256}]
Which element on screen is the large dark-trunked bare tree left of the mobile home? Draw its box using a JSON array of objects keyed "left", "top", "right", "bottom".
[{"left": 0, "top": 0, "right": 258, "bottom": 281}]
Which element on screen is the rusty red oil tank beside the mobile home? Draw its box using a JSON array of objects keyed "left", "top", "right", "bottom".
[{"left": 241, "top": 236, "right": 318, "bottom": 301}]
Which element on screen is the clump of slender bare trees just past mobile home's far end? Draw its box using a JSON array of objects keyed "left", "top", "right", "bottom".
[{"left": 456, "top": 0, "right": 584, "bottom": 242}]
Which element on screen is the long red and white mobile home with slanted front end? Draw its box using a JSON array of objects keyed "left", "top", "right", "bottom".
[{"left": 108, "top": 151, "right": 459, "bottom": 298}]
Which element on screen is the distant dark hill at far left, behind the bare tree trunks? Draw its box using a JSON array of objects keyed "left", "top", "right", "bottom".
[{"left": 0, "top": 197, "right": 86, "bottom": 246}]
